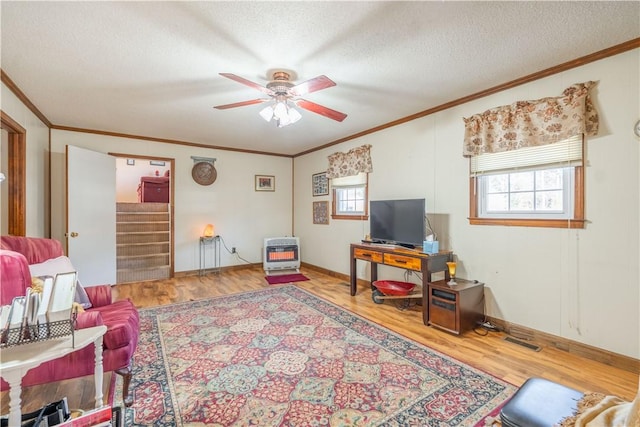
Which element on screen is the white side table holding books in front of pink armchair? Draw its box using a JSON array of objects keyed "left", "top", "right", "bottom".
[{"left": 0, "top": 325, "right": 107, "bottom": 426}]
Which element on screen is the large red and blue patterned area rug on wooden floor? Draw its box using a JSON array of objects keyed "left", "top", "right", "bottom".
[{"left": 116, "top": 285, "right": 515, "bottom": 427}]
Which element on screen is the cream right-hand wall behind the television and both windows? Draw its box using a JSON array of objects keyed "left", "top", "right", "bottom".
[{"left": 294, "top": 49, "right": 640, "bottom": 358}]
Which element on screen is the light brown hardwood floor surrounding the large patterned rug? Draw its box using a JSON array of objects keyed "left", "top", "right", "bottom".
[{"left": 1, "top": 267, "right": 638, "bottom": 414}]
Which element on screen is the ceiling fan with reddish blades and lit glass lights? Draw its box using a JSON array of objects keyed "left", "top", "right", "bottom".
[{"left": 214, "top": 71, "right": 347, "bottom": 127}]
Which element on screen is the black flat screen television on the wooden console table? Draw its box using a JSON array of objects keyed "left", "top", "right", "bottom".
[{"left": 369, "top": 199, "right": 426, "bottom": 248}]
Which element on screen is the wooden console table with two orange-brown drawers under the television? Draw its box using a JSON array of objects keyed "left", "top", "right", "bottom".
[{"left": 350, "top": 243, "right": 451, "bottom": 325}]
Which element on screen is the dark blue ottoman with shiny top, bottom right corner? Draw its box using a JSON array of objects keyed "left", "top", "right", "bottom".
[{"left": 500, "top": 378, "right": 584, "bottom": 427}]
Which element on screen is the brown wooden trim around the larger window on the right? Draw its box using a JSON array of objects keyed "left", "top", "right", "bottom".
[{"left": 468, "top": 166, "right": 586, "bottom": 228}]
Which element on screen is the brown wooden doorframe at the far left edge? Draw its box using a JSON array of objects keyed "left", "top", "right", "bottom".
[{"left": 0, "top": 110, "right": 27, "bottom": 236}]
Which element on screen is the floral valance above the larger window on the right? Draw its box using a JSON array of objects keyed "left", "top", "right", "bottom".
[{"left": 463, "top": 81, "right": 599, "bottom": 157}]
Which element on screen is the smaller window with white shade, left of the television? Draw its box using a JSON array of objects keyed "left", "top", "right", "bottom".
[{"left": 331, "top": 173, "right": 369, "bottom": 220}]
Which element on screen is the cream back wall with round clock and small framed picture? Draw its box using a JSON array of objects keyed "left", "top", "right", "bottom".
[{"left": 51, "top": 130, "right": 292, "bottom": 272}]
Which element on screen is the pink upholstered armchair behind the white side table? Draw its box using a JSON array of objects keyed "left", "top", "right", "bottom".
[{"left": 0, "top": 236, "right": 140, "bottom": 406}]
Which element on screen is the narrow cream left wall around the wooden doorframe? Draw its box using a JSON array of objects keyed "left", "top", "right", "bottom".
[{"left": 0, "top": 78, "right": 49, "bottom": 237}]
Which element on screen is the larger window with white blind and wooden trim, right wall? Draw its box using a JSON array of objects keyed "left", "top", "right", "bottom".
[{"left": 470, "top": 135, "right": 584, "bottom": 228}]
